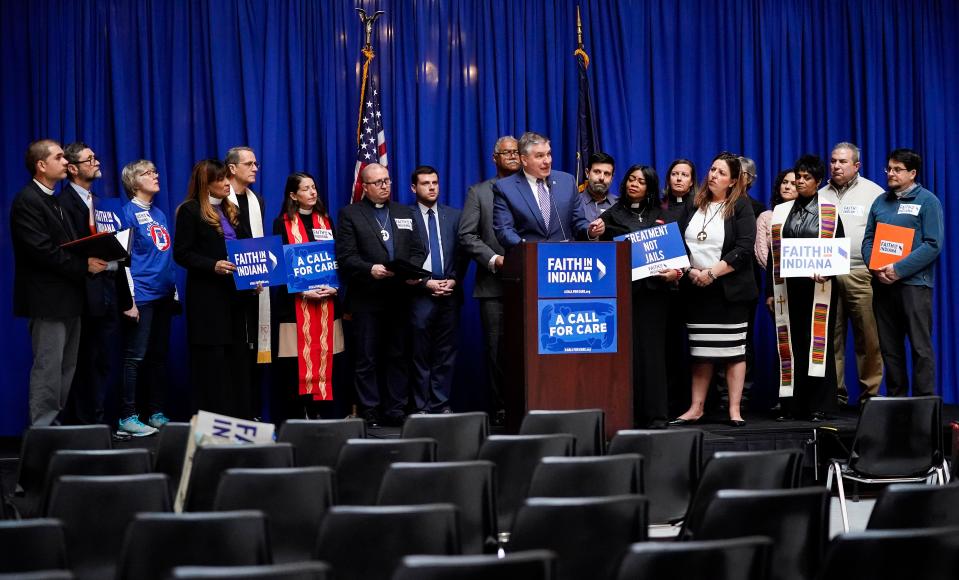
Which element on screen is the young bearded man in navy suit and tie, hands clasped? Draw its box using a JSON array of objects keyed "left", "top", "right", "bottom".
[{"left": 410, "top": 165, "right": 468, "bottom": 413}]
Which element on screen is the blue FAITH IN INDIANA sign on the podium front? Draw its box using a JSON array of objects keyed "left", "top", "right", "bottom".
[{"left": 537, "top": 242, "right": 616, "bottom": 298}]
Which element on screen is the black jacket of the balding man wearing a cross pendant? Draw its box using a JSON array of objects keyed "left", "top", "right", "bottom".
[{"left": 336, "top": 198, "right": 426, "bottom": 312}]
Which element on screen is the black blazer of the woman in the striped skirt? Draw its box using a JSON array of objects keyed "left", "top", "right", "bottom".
[{"left": 679, "top": 197, "right": 759, "bottom": 302}]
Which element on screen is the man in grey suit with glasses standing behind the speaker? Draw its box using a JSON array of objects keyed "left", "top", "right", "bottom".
[{"left": 459, "top": 135, "right": 520, "bottom": 425}]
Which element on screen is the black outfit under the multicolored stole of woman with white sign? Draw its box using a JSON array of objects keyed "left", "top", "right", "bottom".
[{"left": 766, "top": 194, "right": 845, "bottom": 419}]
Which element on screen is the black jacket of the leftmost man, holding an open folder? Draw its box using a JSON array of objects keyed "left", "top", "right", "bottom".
[{"left": 10, "top": 180, "right": 87, "bottom": 318}]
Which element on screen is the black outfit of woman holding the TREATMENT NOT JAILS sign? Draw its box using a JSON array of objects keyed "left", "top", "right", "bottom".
[{"left": 600, "top": 203, "right": 681, "bottom": 427}]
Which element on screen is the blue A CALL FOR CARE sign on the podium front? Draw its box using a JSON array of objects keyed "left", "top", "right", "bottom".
[{"left": 538, "top": 298, "right": 616, "bottom": 354}]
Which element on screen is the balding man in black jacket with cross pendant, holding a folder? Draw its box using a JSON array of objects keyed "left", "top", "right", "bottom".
[{"left": 336, "top": 163, "right": 426, "bottom": 426}]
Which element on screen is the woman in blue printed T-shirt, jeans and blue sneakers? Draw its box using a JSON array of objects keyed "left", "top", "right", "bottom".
[{"left": 119, "top": 159, "right": 177, "bottom": 437}]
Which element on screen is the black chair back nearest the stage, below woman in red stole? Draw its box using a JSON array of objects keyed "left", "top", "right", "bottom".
[{"left": 276, "top": 418, "right": 366, "bottom": 467}]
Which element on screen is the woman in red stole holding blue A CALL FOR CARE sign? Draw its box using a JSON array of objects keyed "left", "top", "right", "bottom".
[{"left": 271, "top": 172, "right": 336, "bottom": 423}]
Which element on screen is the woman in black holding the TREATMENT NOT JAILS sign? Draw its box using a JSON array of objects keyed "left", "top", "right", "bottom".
[{"left": 600, "top": 165, "right": 683, "bottom": 429}]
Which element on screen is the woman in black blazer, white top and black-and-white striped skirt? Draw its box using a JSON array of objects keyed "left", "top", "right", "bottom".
[{"left": 670, "top": 153, "right": 757, "bottom": 427}]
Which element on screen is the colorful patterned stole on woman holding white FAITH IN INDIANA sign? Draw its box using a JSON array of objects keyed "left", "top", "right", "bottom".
[{"left": 771, "top": 199, "right": 836, "bottom": 397}]
